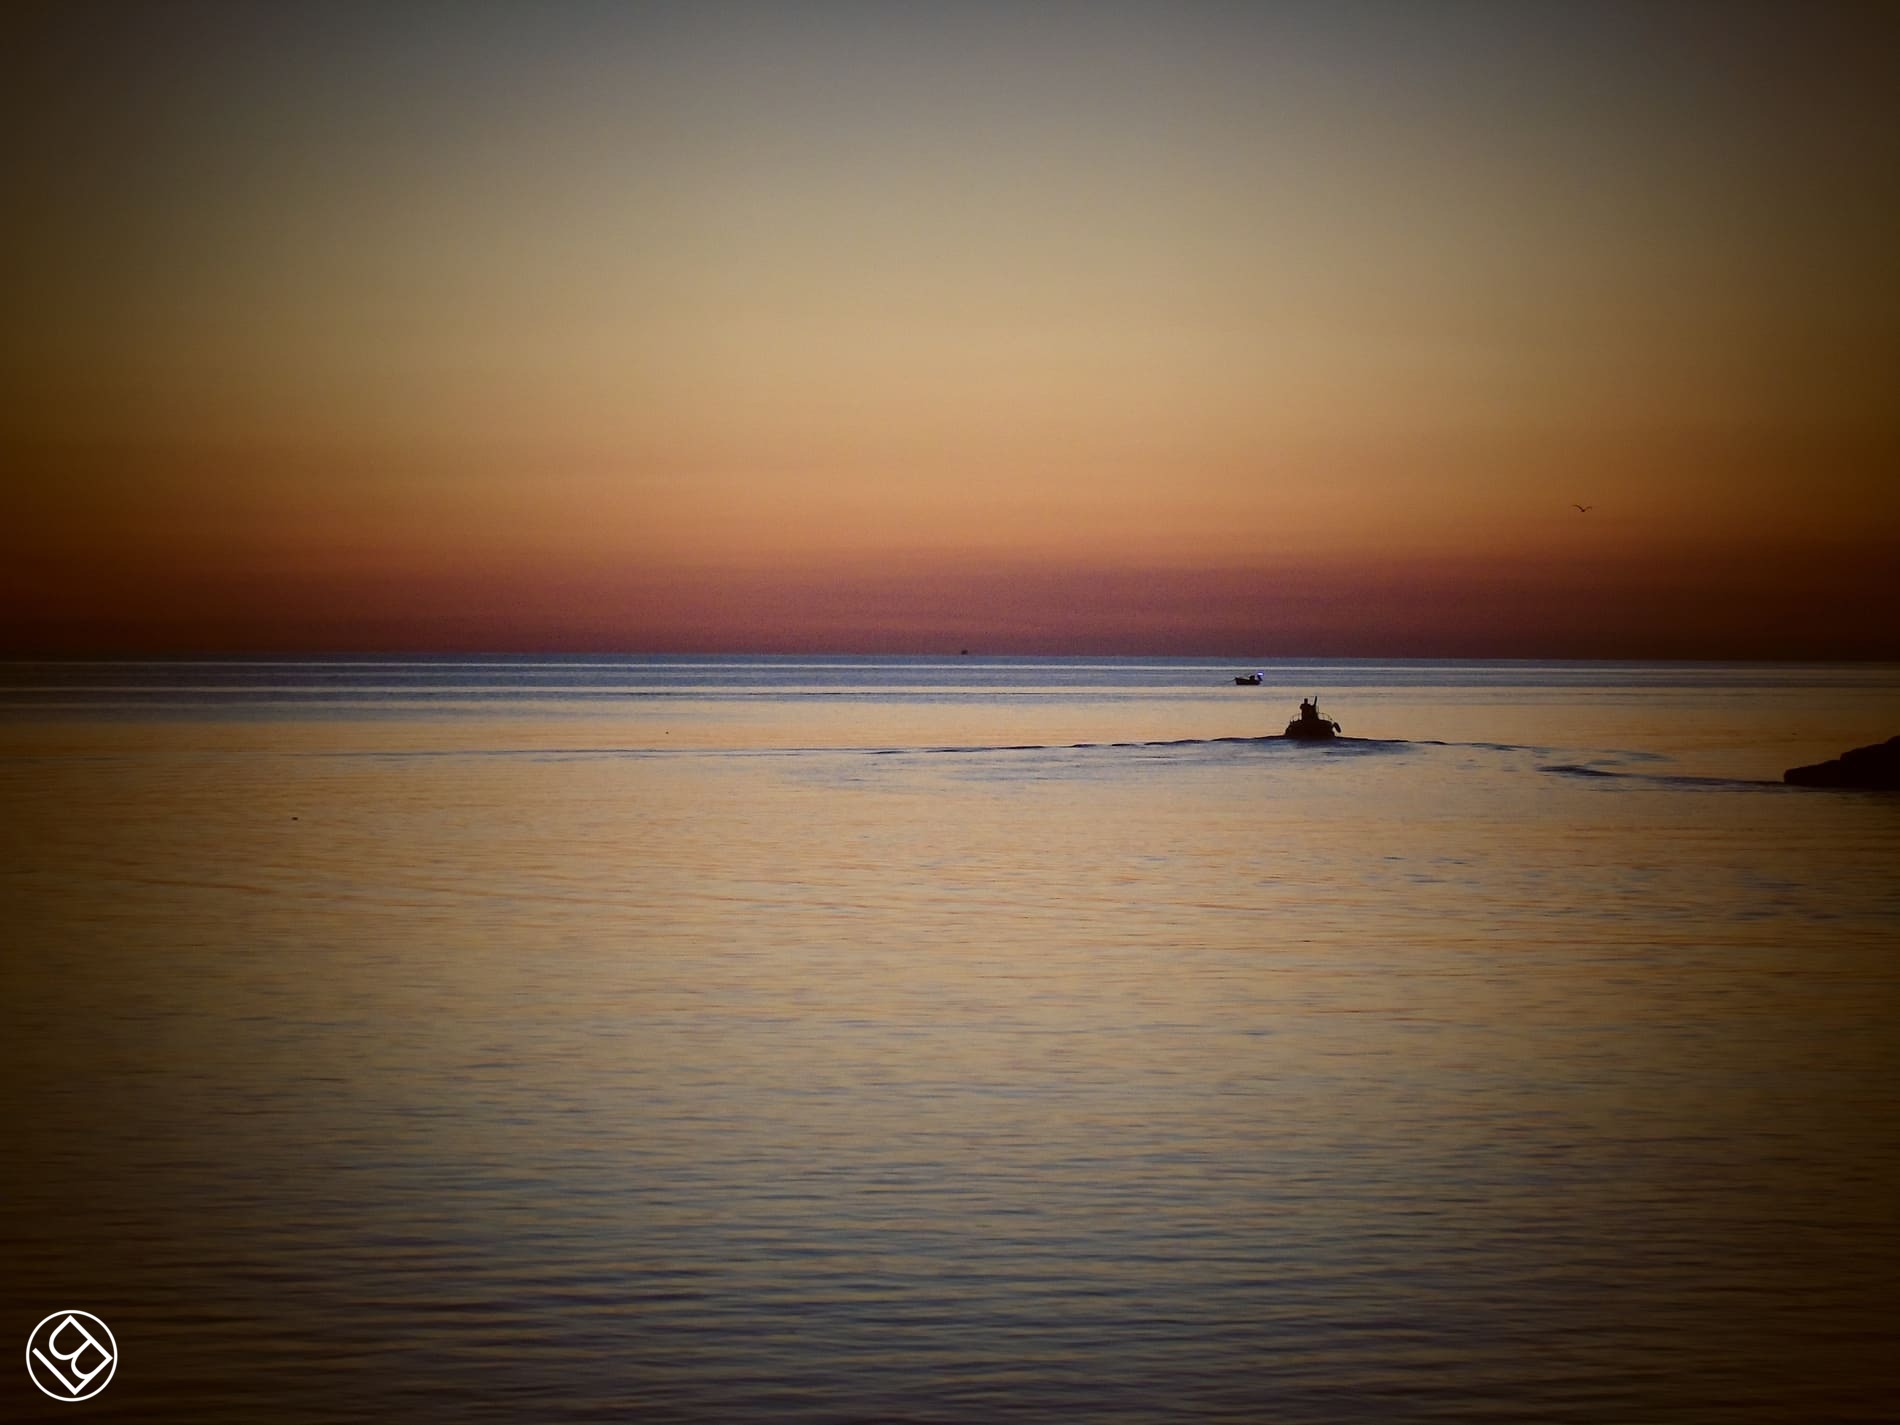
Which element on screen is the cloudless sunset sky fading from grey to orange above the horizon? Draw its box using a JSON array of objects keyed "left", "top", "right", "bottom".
[{"left": 0, "top": 0, "right": 1900, "bottom": 657}]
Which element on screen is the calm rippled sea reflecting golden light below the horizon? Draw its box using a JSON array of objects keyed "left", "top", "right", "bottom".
[{"left": 0, "top": 657, "right": 1900, "bottom": 1425}]
